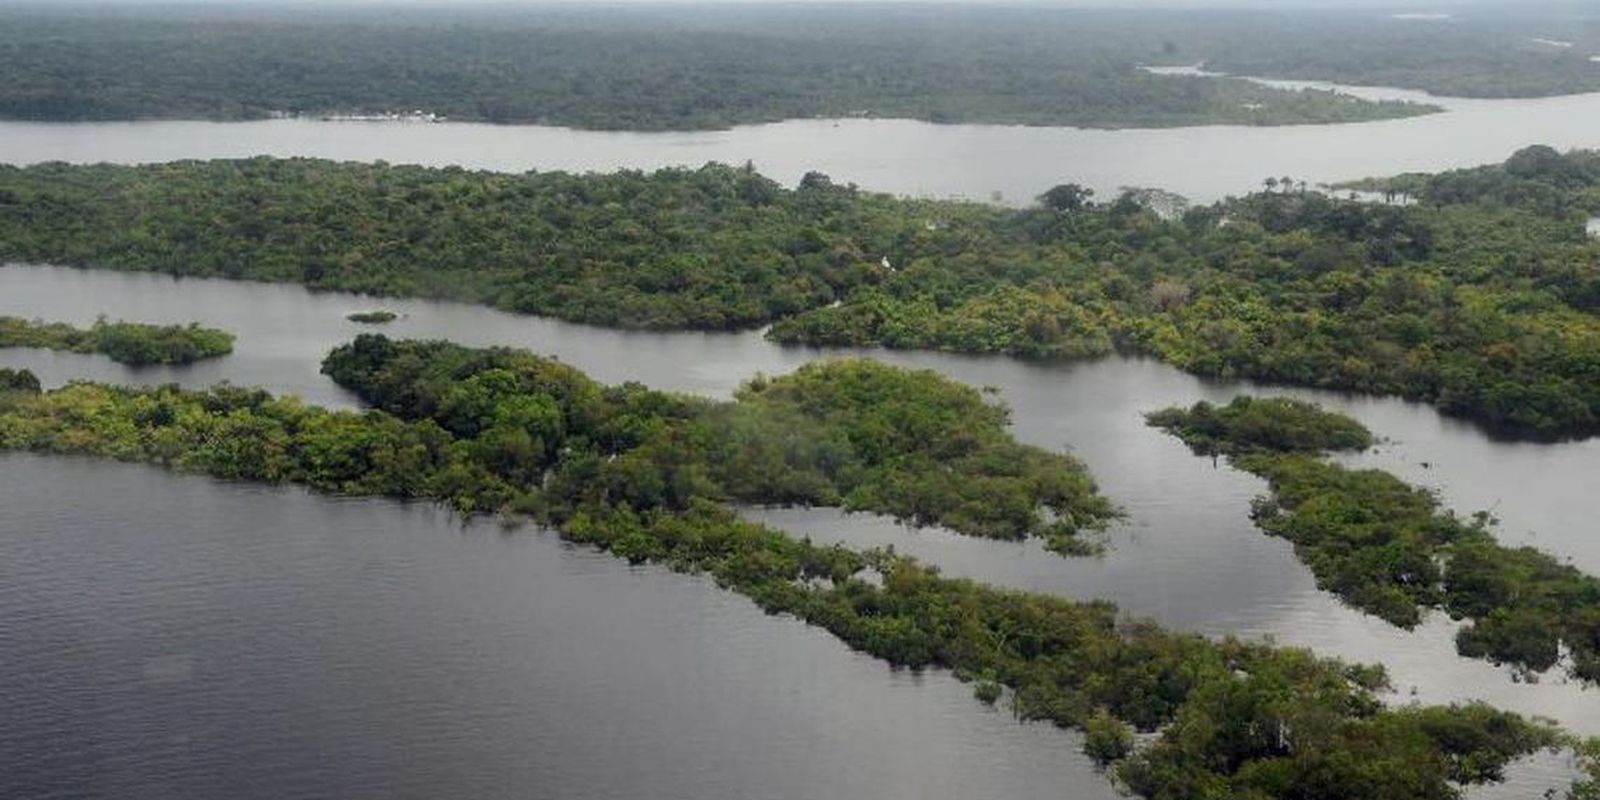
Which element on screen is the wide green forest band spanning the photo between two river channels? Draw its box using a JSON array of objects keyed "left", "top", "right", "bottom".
[{"left": 9, "top": 147, "right": 1600, "bottom": 437}]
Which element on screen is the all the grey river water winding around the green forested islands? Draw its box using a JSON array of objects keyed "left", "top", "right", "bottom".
[{"left": 0, "top": 90, "right": 1600, "bottom": 798}]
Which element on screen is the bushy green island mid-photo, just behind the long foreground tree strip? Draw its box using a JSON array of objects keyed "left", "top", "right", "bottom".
[{"left": 323, "top": 336, "right": 1115, "bottom": 554}]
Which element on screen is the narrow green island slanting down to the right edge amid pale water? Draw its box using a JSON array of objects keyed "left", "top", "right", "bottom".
[{"left": 1149, "top": 397, "right": 1600, "bottom": 683}]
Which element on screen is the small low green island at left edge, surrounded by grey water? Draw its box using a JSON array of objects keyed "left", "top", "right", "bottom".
[{"left": 0, "top": 317, "right": 234, "bottom": 366}]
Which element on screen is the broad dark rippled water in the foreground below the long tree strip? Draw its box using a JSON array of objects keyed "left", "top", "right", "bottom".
[{"left": 0, "top": 454, "right": 1115, "bottom": 800}]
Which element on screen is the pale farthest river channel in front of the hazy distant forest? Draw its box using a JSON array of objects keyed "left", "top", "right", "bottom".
[{"left": 0, "top": 82, "right": 1600, "bottom": 203}]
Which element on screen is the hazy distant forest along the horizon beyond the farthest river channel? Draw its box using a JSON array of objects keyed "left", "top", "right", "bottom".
[{"left": 0, "top": 5, "right": 1600, "bottom": 130}]
